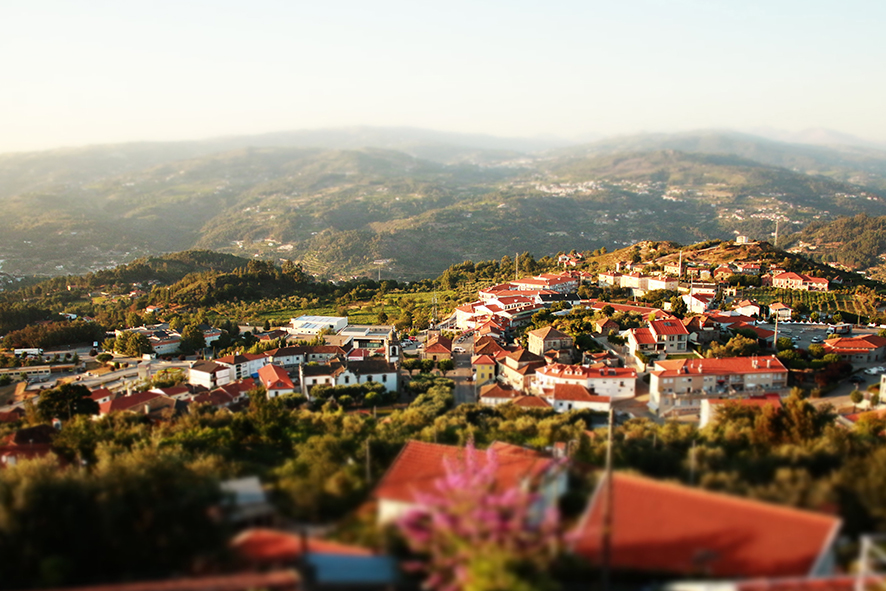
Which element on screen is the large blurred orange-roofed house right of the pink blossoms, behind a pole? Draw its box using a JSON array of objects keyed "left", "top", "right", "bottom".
[{"left": 572, "top": 472, "right": 840, "bottom": 579}]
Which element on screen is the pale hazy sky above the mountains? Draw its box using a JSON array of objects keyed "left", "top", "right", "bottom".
[{"left": 0, "top": 0, "right": 886, "bottom": 151}]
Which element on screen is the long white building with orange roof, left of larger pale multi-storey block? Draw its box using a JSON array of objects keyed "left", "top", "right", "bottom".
[{"left": 534, "top": 363, "right": 637, "bottom": 400}]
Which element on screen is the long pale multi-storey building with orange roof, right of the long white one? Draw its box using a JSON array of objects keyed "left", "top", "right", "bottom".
[{"left": 649, "top": 355, "right": 788, "bottom": 416}]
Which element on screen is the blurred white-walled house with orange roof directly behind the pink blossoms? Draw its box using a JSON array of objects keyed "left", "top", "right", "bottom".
[{"left": 373, "top": 441, "right": 566, "bottom": 524}]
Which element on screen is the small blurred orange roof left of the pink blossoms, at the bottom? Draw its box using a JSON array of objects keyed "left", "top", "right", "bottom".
[{"left": 231, "top": 528, "right": 372, "bottom": 564}]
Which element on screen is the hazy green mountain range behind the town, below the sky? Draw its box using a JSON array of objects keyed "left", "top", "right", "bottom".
[{"left": 0, "top": 128, "right": 886, "bottom": 279}]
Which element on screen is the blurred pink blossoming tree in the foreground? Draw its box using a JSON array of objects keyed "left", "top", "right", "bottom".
[{"left": 399, "top": 443, "right": 561, "bottom": 591}]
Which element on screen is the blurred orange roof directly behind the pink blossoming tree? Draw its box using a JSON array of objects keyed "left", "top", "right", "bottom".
[{"left": 374, "top": 441, "right": 553, "bottom": 503}]
